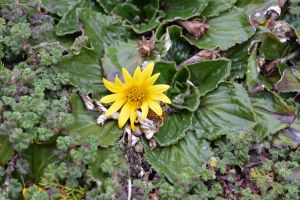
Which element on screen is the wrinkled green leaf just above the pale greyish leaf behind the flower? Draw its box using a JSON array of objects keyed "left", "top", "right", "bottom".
[{"left": 78, "top": 9, "right": 127, "bottom": 55}]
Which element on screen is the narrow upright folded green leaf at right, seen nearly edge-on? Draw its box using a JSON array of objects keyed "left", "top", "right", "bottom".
[{"left": 246, "top": 43, "right": 261, "bottom": 93}]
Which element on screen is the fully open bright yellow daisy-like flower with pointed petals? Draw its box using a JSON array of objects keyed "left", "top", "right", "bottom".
[{"left": 100, "top": 63, "right": 171, "bottom": 129}]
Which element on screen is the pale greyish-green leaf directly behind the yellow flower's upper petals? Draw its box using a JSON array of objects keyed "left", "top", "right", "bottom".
[{"left": 102, "top": 40, "right": 142, "bottom": 81}]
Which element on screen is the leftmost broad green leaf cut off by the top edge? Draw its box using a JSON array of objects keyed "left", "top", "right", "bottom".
[{"left": 41, "top": 0, "right": 77, "bottom": 17}]
